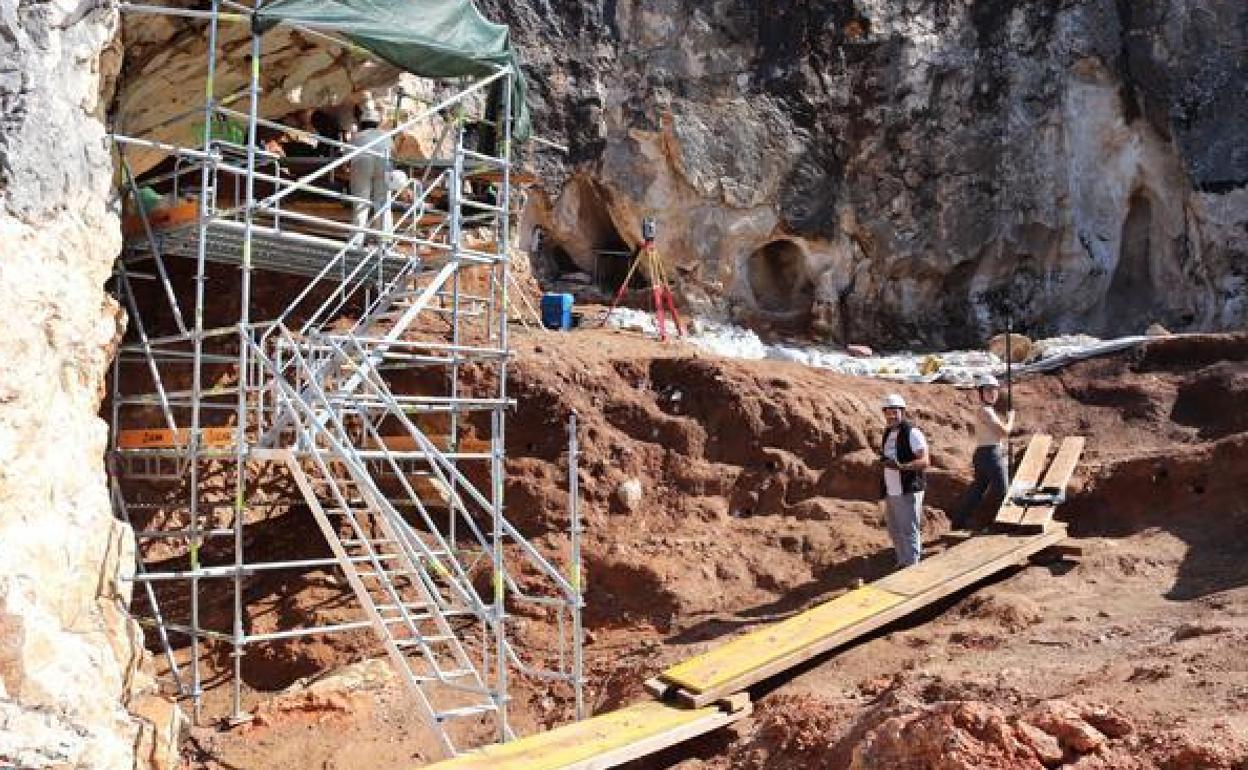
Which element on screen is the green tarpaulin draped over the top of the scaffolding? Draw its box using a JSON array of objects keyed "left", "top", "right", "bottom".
[{"left": 257, "top": 0, "right": 529, "bottom": 141}]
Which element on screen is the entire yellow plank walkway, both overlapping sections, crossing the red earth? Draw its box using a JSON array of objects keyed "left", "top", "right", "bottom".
[{"left": 433, "top": 524, "right": 1066, "bottom": 770}]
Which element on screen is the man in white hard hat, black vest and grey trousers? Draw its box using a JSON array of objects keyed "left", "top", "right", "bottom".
[{"left": 880, "top": 393, "right": 929, "bottom": 567}]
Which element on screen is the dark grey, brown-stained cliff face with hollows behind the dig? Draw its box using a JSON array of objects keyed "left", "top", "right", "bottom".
[{"left": 482, "top": 0, "right": 1248, "bottom": 344}]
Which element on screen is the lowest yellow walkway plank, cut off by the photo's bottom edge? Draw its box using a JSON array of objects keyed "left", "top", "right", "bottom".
[{"left": 431, "top": 701, "right": 750, "bottom": 770}]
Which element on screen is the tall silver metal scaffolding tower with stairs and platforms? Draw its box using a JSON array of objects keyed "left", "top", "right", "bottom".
[{"left": 109, "top": 0, "right": 583, "bottom": 755}]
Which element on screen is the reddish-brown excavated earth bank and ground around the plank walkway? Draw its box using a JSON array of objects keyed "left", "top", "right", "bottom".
[{"left": 168, "top": 329, "right": 1248, "bottom": 770}]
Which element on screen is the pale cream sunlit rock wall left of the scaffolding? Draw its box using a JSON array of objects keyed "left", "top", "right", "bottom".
[{"left": 0, "top": 0, "right": 181, "bottom": 770}]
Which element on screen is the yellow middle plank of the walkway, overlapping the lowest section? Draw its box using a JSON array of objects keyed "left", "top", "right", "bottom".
[{"left": 661, "top": 585, "right": 905, "bottom": 694}]
